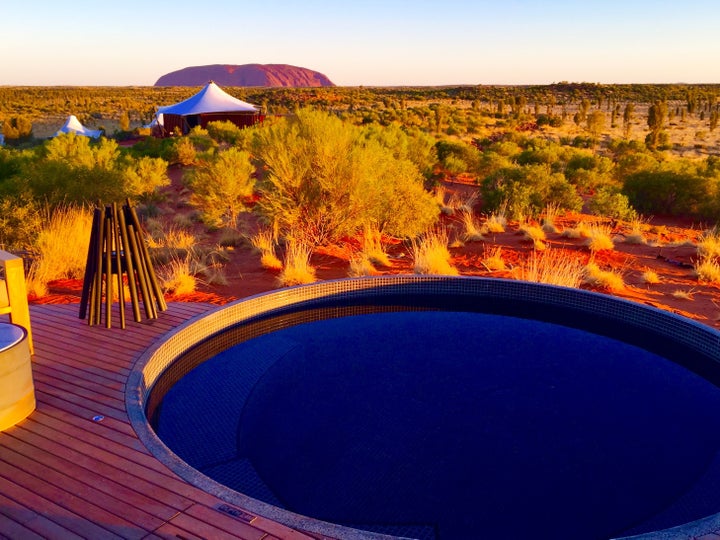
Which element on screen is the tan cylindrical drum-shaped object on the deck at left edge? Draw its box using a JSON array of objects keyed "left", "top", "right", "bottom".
[{"left": 0, "top": 323, "right": 35, "bottom": 431}]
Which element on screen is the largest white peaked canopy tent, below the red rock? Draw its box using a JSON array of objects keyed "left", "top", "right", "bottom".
[{"left": 155, "top": 81, "right": 265, "bottom": 134}]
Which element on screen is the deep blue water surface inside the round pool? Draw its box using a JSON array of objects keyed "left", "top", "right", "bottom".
[{"left": 156, "top": 311, "right": 720, "bottom": 539}]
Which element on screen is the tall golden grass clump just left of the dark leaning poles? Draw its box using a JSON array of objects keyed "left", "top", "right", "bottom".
[{"left": 27, "top": 206, "right": 92, "bottom": 297}]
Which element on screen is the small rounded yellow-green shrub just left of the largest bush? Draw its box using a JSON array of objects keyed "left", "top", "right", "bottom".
[{"left": 184, "top": 148, "right": 255, "bottom": 227}]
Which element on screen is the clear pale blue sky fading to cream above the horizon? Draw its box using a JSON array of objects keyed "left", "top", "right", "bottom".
[{"left": 5, "top": 0, "right": 720, "bottom": 86}]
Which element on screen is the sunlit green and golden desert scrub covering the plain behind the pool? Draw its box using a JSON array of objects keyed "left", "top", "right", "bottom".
[{"left": 0, "top": 83, "right": 720, "bottom": 306}]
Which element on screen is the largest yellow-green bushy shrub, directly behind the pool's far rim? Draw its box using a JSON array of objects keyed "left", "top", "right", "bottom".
[{"left": 254, "top": 110, "right": 438, "bottom": 245}]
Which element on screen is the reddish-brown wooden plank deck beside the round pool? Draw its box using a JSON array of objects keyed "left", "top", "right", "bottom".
[{"left": 0, "top": 303, "right": 318, "bottom": 540}]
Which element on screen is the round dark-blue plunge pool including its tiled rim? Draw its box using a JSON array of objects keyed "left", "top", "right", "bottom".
[{"left": 128, "top": 277, "right": 720, "bottom": 539}]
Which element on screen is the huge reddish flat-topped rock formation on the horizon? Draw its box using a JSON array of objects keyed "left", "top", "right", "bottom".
[{"left": 155, "top": 64, "right": 335, "bottom": 88}]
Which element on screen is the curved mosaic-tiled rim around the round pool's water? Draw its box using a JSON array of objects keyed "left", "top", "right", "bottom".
[{"left": 125, "top": 275, "right": 720, "bottom": 540}]
